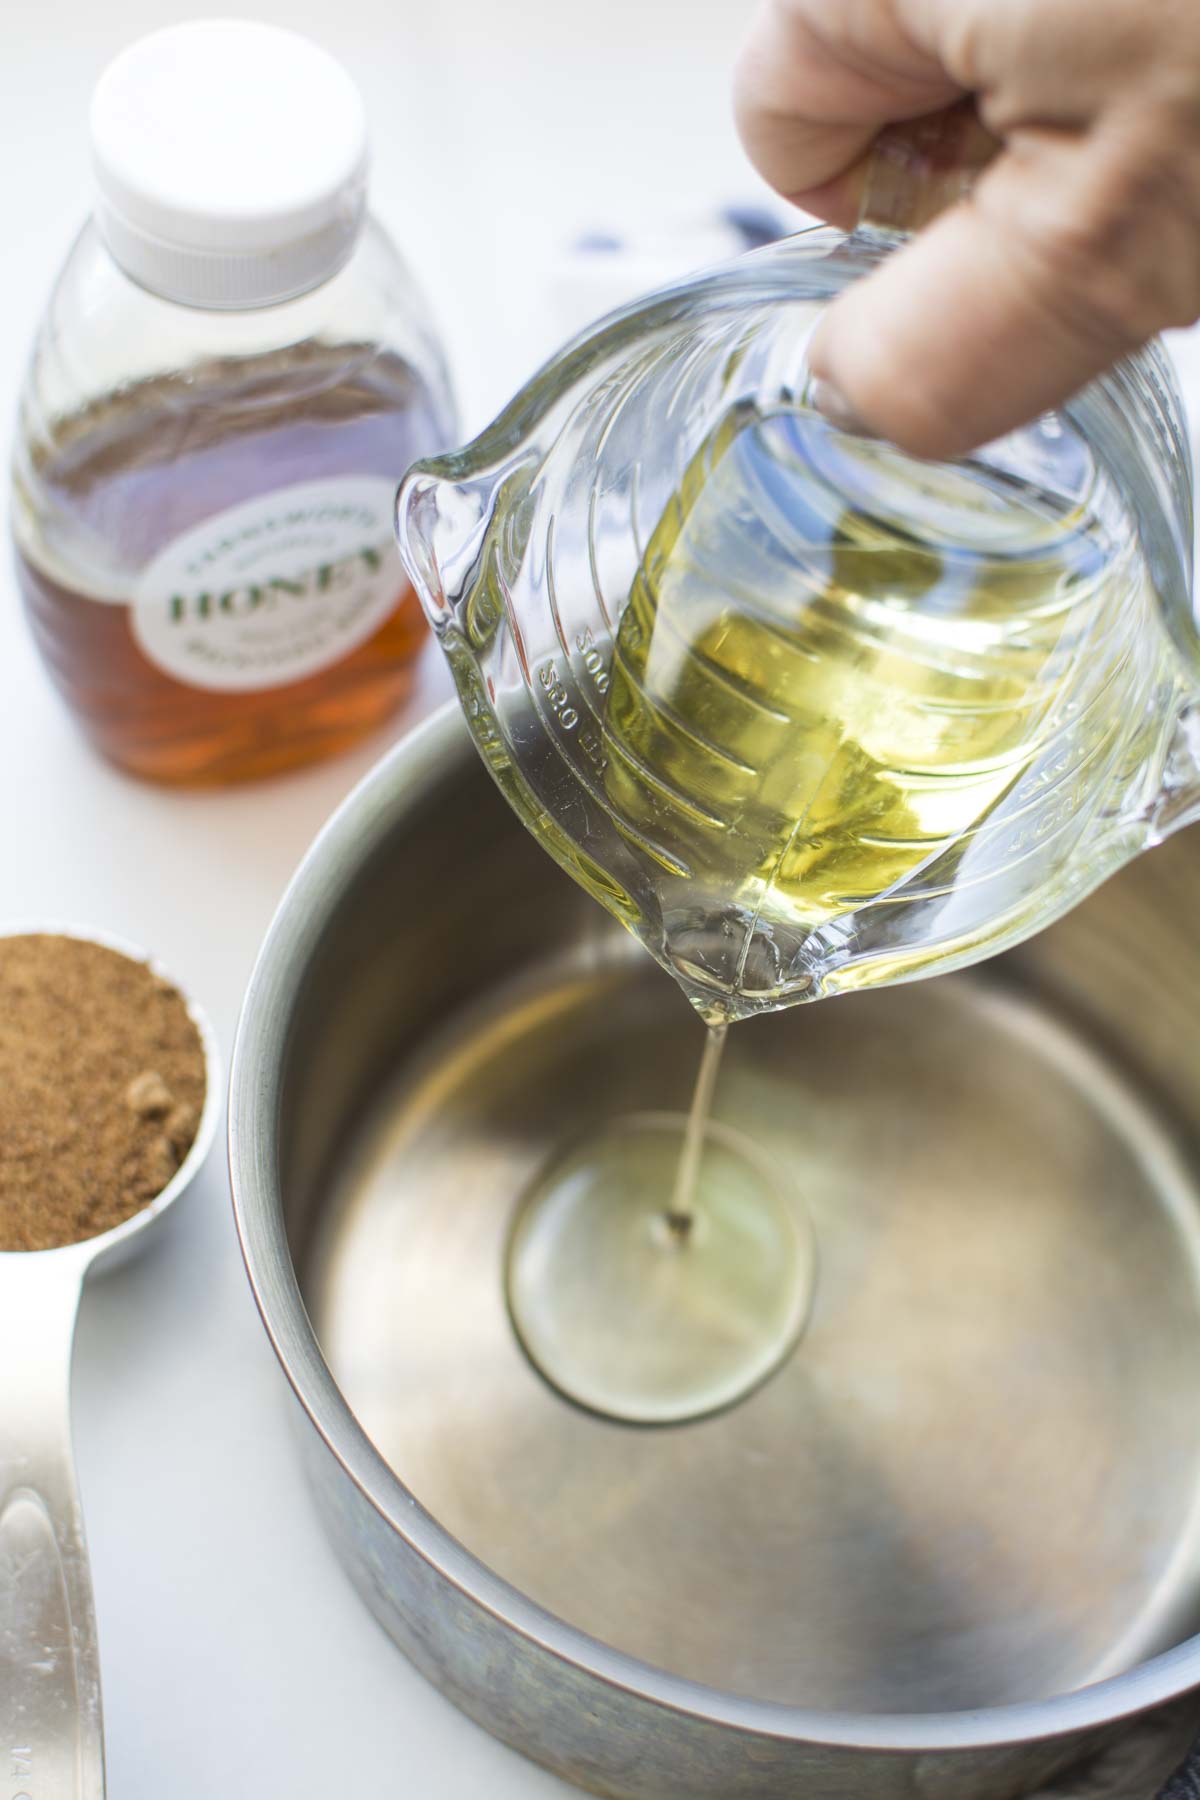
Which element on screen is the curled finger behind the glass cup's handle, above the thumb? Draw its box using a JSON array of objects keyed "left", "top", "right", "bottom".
[{"left": 734, "top": 0, "right": 963, "bottom": 229}]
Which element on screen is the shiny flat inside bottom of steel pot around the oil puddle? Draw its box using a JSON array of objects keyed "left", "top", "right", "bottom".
[{"left": 314, "top": 959, "right": 1200, "bottom": 1712}]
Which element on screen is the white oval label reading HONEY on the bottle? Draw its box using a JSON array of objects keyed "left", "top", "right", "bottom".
[{"left": 130, "top": 475, "right": 405, "bottom": 693}]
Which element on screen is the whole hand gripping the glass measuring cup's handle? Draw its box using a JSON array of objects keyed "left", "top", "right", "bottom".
[{"left": 736, "top": 0, "right": 1200, "bottom": 457}]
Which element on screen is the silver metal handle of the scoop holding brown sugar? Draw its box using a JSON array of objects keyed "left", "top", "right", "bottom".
[{"left": 0, "top": 1244, "right": 104, "bottom": 1800}]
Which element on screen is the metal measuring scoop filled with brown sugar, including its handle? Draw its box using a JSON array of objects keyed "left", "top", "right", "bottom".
[{"left": 0, "top": 927, "right": 219, "bottom": 1800}]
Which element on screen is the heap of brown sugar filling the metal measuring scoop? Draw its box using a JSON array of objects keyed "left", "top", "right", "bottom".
[{"left": 0, "top": 934, "right": 205, "bottom": 1251}]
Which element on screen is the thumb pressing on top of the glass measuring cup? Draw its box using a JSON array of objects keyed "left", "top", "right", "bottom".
[{"left": 808, "top": 151, "right": 1144, "bottom": 457}]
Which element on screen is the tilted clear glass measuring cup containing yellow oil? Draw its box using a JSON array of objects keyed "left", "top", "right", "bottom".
[{"left": 398, "top": 119, "right": 1200, "bottom": 1021}]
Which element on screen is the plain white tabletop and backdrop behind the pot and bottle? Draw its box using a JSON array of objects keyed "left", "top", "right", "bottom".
[{"left": 0, "top": 0, "right": 1196, "bottom": 1800}]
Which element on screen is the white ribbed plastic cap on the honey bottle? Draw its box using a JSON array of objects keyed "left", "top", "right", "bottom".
[{"left": 92, "top": 18, "right": 367, "bottom": 308}]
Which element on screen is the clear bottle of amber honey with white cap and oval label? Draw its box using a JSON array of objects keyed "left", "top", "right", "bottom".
[{"left": 11, "top": 20, "right": 455, "bottom": 783}]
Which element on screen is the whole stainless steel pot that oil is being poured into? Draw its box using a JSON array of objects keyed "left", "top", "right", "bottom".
[{"left": 230, "top": 715, "right": 1200, "bottom": 1800}]
